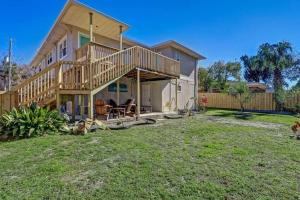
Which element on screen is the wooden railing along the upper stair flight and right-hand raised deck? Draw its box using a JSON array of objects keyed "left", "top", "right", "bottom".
[{"left": 91, "top": 46, "right": 180, "bottom": 89}]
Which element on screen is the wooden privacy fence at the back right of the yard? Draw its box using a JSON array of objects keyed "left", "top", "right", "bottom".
[{"left": 199, "top": 93, "right": 300, "bottom": 111}]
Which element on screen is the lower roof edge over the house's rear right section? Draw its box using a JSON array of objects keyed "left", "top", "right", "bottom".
[{"left": 151, "top": 40, "right": 206, "bottom": 60}]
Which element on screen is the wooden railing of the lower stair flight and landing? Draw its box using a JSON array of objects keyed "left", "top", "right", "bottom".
[{"left": 13, "top": 61, "right": 90, "bottom": 106}]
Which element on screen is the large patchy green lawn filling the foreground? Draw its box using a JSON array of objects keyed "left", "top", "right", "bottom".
[{"left": 0, "top": 115, "right": 300, "bottom": 200}]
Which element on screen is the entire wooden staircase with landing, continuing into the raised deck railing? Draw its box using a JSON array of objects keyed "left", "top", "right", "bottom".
[{"left": 5, "top": 46, "right": 180, "bottom": 110}]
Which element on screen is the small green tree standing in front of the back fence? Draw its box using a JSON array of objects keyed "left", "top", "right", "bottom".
[{"left": 228, "top": 81, "right": 251, "bottom": 112}]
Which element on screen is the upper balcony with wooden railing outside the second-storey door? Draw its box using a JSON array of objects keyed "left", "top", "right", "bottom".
[{"left": 75, "top": 42, "right": 180, "bottom": 77}]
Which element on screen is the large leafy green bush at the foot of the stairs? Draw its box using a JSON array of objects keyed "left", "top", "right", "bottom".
[{"left": 0, "top": 104, "right": 66, "bottom": 139}]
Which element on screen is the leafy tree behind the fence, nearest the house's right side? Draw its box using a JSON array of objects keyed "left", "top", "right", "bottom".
[{"left": 208, "top": 61, "right": 241, "bottom": 91}]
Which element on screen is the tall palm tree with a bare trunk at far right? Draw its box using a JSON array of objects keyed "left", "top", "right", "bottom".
[{"left": 257, "top": 42, "right": 298, "bottom": 110}]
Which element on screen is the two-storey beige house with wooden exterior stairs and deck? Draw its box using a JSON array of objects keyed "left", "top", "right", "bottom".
[{"left": 7, "top": 0, "right": 205, "bottom": 120}]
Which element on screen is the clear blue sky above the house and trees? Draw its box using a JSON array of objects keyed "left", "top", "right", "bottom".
[{"left": 0, "top": 0, "right": 300, "bottom": 66}]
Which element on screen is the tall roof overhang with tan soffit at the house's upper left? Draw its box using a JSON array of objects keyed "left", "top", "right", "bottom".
[{"left": 30, "top": 0, "right": 129, "bottom": 66}]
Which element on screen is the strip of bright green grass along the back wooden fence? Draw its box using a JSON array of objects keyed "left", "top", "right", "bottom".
[{"left": 206, "top": 109, "right": 300, "bottom": 126}]
